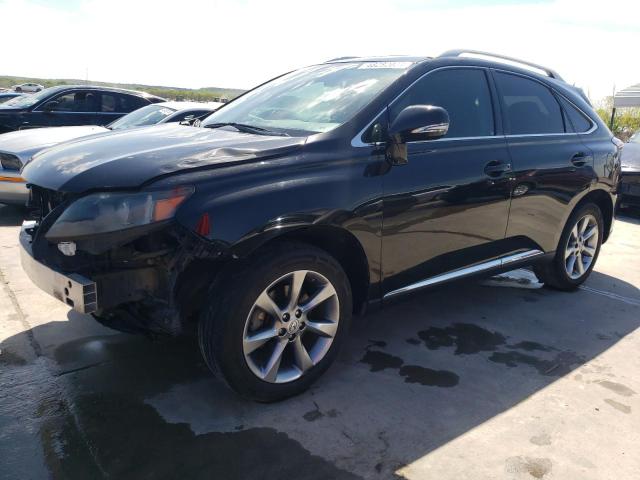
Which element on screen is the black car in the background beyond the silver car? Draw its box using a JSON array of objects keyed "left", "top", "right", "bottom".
[{"left": 0, "top": 85, "right": 165, "bottom": 133}]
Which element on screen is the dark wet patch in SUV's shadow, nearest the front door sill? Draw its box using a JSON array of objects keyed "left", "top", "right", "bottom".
[{"left": 418, "top": 323, "right": 506, "bottom": 355}]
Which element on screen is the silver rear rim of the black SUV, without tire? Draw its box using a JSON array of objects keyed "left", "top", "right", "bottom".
[{"left": 564, "top": 214, "right": 599, "bottom": 280}]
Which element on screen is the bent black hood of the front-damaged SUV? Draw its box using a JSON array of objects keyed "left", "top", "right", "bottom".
[{"left": 22, "top": 124, "right": 306, "bottom": 193}]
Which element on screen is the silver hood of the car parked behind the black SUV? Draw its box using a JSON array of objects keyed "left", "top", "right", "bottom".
[{"left": 0, "top": 126, "right": 109, "bottom": 162}]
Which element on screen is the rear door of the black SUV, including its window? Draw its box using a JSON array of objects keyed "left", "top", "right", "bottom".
[{"left": 493, "top": 70, "right": 594, "bottom": 251}]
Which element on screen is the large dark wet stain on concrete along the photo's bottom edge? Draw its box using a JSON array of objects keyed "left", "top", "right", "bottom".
[{"left": 49, "top": 394, "right": 359, "bottom": 480}]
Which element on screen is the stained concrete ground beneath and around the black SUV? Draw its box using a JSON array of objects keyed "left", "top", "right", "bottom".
[{"left": 0, "top": 206, "right": 640, "bottom": 480}]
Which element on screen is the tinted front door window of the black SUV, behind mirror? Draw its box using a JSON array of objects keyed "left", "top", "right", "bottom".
[{"left": 391, "top": 68, "right": 495, "bottom": 138}]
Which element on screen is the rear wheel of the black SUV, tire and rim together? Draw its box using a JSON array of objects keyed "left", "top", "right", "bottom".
[{"left": 534, "top": 203, "right": 604, "bottom": 291}]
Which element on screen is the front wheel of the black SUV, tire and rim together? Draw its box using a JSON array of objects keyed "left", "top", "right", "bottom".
[{"left": 198, "top": 242, "right": 352, "bottom": 402}]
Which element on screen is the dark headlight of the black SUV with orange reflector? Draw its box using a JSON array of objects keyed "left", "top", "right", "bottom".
[{"left": 45, "top": 187, "right": 194, "bottom": 242}]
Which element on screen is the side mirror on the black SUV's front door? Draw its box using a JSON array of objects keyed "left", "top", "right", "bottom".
[{"left": 389, "top": 105, "right": 449, "bottom": 144}]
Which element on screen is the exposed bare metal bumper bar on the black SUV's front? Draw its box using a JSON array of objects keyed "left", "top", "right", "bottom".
[{"left": 20, "top": 222, "right": 98, "bottom": 313}]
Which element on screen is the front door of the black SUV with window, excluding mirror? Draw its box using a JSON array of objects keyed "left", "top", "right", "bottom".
[{"left": 382, "top": 67, "right": 511, "bottom": 294}]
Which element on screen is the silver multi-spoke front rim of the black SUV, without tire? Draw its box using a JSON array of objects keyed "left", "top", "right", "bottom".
[{"left": 242, "top": 270, "right": 340, "bottom": 383}]
